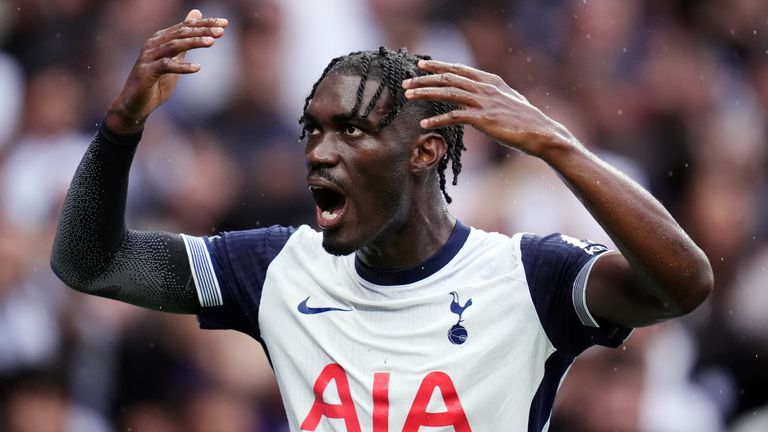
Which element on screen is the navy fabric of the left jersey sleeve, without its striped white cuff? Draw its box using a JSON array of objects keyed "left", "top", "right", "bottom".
[{"left": 198, "top": 225, "right": 296, "bottom": 340}]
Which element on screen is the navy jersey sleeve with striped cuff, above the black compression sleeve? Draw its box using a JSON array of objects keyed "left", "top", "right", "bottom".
[{"left": 182, "top": 226, "right": 295, "bottom": 339}]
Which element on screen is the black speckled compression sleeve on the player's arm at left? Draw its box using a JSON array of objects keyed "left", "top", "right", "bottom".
[{"left": 51, "top": 124, "right": 199, "bottom": 313}]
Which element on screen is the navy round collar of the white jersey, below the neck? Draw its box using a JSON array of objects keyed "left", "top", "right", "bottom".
[{"left": 355, "top": 220, "right": 470, "bottom": 285}]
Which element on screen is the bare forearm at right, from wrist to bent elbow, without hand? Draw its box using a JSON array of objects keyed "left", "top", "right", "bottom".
[{"left": 540, "top": 141, "right": 712, "bottom": 319}]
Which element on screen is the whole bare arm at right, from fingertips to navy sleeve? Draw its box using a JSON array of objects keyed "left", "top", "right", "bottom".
[{"left": 403, "top": 61, "right": 714, "bottom": 327}]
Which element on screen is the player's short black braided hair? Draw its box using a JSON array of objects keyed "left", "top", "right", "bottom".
[{"left": 299, "top": 47, "right": 467, "bottom": 203}]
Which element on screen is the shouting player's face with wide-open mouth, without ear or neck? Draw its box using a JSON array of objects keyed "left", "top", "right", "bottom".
[{"left": 303, "top": 75, "right": 418, "bottom": 255}]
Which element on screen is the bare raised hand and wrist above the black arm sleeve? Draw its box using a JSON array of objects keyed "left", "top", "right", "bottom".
[{"left": 105, "top": 9, "right": 228, "bottom": 135}]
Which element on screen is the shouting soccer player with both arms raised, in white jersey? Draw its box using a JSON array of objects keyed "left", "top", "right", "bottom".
[{"left": 52, "top": 10, "right": 713, "bottom": 432}]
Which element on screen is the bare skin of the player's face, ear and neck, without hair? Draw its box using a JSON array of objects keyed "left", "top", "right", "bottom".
[{"left": 303, "top": 75, "right": 455, "bottom": 269}]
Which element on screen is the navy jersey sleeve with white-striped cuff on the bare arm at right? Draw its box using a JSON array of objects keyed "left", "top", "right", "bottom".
[{"left": 520, "top": 233, "right": 631, "bottom": 355}]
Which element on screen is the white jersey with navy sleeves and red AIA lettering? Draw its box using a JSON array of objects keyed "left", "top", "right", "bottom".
[{"left": 184, "top": 222, "right": 630, "bottom": 432}]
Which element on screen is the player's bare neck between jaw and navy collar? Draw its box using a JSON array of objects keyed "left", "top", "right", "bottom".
[{"left": 357, "top": 196, "right": 456, "bottom": 270}]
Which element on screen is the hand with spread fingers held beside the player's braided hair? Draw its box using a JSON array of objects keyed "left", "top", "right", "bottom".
[{"left": 403, "top": 60, "right": 577, "bottom": 156}]
